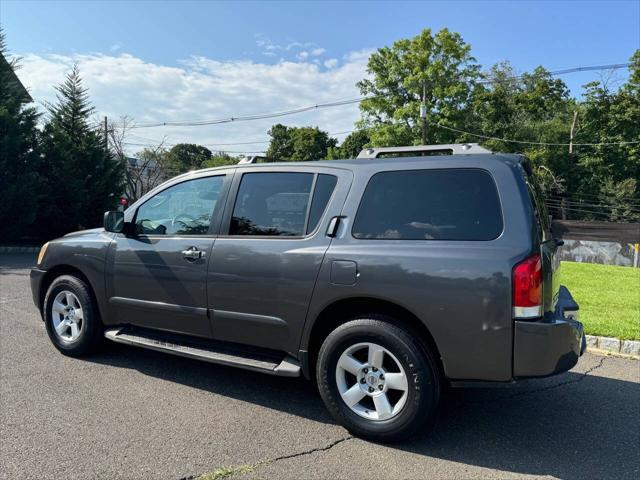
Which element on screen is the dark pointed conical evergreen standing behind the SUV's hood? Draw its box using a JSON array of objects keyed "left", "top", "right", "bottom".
[{"left": 39, "top": 65, "right": 123, "bottom": 236}]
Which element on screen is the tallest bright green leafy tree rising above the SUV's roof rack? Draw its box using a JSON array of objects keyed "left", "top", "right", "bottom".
[{"left": 357, "top": 28, "right": 480, "bottom": 146}]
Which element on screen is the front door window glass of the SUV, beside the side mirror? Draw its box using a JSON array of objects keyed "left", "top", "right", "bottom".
[{"left": 136, "top": 175, "right": 224, "bottom": 235}]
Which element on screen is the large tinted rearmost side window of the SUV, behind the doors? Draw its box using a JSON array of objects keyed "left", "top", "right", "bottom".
[{"left": 352, "top": 169, "right": 503, "bottom": 240}]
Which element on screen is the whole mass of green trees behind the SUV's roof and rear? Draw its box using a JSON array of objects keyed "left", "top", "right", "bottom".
[{"left": 358, "top": 29, "right": 640, "bottom": 221}]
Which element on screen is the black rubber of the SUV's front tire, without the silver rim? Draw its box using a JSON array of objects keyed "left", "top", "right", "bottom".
[{"left": 43, "top": 275, "right": 103, "bottom": 357}]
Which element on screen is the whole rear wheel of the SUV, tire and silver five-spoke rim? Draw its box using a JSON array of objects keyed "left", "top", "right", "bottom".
[{"left": 316, "top": 316, "right": 440, "bottom": 442}]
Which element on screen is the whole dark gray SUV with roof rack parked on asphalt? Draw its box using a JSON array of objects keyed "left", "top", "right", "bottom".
[{"left": 31, "top": 149, "right": 585, "bottom": 441}]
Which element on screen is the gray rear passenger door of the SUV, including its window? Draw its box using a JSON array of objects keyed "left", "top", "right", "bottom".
[{"left": 208, "top": 166, "right": 352, "bottom": 353}]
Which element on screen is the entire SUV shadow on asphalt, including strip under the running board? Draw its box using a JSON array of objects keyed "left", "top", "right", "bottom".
[{"left": 88, "top": 344, "right": 640, "bottom": 479}]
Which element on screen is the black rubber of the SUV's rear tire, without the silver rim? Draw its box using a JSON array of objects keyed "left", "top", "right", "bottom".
[{"left": 316, "top": 315, "right": 441, "bottom": 442}]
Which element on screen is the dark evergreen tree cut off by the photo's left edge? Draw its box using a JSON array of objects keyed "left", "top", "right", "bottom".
[{"left": 0, "top": 29, "right": 40, "bottom": 243}]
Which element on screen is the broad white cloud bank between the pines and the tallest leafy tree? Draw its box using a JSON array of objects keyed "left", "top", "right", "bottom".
[{"left": 19, "top": 51, "right": 370, "bottom": 151}]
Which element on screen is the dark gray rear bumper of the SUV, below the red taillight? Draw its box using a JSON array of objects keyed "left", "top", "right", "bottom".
[{"left": 513, "top": 287, "right": 586, "bottom": 378}]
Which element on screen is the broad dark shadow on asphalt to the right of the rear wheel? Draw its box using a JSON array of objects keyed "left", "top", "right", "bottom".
[{"left": 408, "top": 362, "right": 640, "bottom": 479}]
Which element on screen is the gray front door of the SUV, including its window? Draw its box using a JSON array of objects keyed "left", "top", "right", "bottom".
[{"left": 107, "top": 172, "right": 232, "bottom": 337}]
